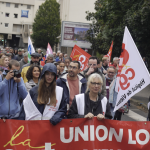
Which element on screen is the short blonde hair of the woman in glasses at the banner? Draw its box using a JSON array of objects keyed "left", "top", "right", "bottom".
[{"left": 86, "top": 73, "right": 103, "bottom": 92}]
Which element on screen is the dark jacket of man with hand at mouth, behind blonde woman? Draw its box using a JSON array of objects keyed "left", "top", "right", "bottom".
[{"left": 82, "top": 68, "right": 106, "bottom": 96}]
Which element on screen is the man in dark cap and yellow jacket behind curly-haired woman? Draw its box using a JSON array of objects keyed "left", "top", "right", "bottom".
[{"left": 21, "top": 53, "right": 43, "bottom": 83}]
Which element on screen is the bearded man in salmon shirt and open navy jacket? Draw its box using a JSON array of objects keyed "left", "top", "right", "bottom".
[{"left": 56, "top": 61, "right": 87, "bottom": 108}]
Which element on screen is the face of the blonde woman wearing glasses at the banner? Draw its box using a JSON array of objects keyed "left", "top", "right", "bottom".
[{"left": 89, "top": 78, "right": 102, "bottom": 94}]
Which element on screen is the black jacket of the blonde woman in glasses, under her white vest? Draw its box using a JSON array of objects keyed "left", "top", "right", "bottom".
[{"left": 68, "top": 93, "right": 112, "bottom": 119}]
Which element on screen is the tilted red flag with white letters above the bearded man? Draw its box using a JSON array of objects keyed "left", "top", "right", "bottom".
[{"left": 70, "top": 45, "right": 91, "bottom": 71}]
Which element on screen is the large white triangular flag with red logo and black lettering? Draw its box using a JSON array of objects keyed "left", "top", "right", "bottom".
[{"left": 114, "top": 27, "right": 150, "bottom": 111}]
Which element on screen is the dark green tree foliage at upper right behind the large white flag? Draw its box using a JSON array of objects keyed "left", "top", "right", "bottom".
[{"left": 86, "top": 0, "right": 150, "bottom": 56}]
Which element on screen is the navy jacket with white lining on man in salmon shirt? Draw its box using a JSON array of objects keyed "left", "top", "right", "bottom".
[{"left": 56, "top": 73, "right": 87, "bottom": 104}]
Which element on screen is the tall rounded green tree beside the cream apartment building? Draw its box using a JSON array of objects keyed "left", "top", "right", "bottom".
[{"left": 31, "top": 0, "right": 61, "bottom": 49}]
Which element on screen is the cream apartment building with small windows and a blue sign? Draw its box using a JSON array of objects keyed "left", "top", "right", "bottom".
[{"left": 0, "top": 0, "right": 45, "bottom": 47}]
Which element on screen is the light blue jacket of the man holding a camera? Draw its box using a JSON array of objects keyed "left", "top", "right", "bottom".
[{"left": 0, "top": 71, "right": 27, "bottom": 118}]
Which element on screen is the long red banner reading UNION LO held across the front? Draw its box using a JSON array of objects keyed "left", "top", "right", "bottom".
[{"left": 0, "top": 118, "right": 150, "bottom": 150}]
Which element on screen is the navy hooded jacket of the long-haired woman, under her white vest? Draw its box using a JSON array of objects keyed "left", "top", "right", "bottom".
[{"left": 18, "top": 63, "right": 68, "bottom": 125}]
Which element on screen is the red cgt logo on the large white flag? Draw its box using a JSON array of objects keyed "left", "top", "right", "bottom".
[{"left": 117, "top": 43, "right": 135, "bottom": 91}]
